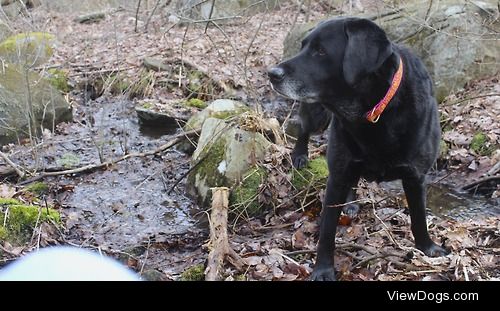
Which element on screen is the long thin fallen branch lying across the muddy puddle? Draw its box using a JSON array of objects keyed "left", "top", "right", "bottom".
[{"left": 18, "top": 129, "right": 200, "bottom": 185}]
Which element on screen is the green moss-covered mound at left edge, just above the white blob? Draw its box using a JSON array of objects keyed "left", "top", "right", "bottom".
[{"left": 0, "top": 199, "right": 61, "bottom": 243}]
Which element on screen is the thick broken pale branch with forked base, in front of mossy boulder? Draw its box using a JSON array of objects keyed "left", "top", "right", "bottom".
[{"left": 205, "top": 187, "right": 243, "bottom": 281}]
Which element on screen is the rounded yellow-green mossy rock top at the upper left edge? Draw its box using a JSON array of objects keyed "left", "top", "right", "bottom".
[{"left": 0, "top": 32, "right": 55, "bottom": 67}]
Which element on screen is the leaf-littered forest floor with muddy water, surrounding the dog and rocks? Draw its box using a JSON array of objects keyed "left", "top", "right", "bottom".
[{"left": 0, "top": 1, "right": 500, "bottom": 280}]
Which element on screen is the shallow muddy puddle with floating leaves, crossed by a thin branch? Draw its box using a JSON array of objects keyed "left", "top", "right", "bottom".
[{"left": 48, "top": 100, "right": 200, "bottom": 249}]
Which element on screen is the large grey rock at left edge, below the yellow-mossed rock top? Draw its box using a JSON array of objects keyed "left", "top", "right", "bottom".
[{"left": 0, "top": 64, "right": 72, "bottom": 145}]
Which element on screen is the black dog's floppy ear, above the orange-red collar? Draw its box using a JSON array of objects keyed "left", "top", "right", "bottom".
[{"left": 342, "top": 19, "right": 392, "bottom": 85}]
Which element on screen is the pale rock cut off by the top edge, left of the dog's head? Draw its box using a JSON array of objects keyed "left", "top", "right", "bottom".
[{"left": 176, "top": 0, "right": 279, "bottom": 19}]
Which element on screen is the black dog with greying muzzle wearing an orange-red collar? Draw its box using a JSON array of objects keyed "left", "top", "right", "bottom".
[{"left": 268, "top": 18, "right": 447, "bottom": 280}]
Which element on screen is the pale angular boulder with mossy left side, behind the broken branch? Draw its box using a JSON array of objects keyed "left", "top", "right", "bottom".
[{"left": 188, "top": 118, "right": 271, "bottom": 206}]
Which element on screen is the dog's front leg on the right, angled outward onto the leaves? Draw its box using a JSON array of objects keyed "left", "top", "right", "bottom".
[{"left": 403, "top": 177, "right": 448, "bottom": 257}]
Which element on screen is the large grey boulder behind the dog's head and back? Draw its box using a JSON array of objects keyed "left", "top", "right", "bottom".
[{"left": 283, "top": 0, "right": 500, "bottom": 101}]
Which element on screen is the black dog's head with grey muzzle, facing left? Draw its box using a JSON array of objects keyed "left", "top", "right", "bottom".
[{"left": 268, "top": 18, "right": 393, "bottom": 103}]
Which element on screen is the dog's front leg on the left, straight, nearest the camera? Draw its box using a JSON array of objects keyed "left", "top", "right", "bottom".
[{"left": 311, "top": 175, "right": 353, "bottom": 281}]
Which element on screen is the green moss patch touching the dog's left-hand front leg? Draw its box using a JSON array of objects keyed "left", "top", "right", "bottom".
[{"left": 292, "top": 157, "right": 328, "bottom": 190}]
